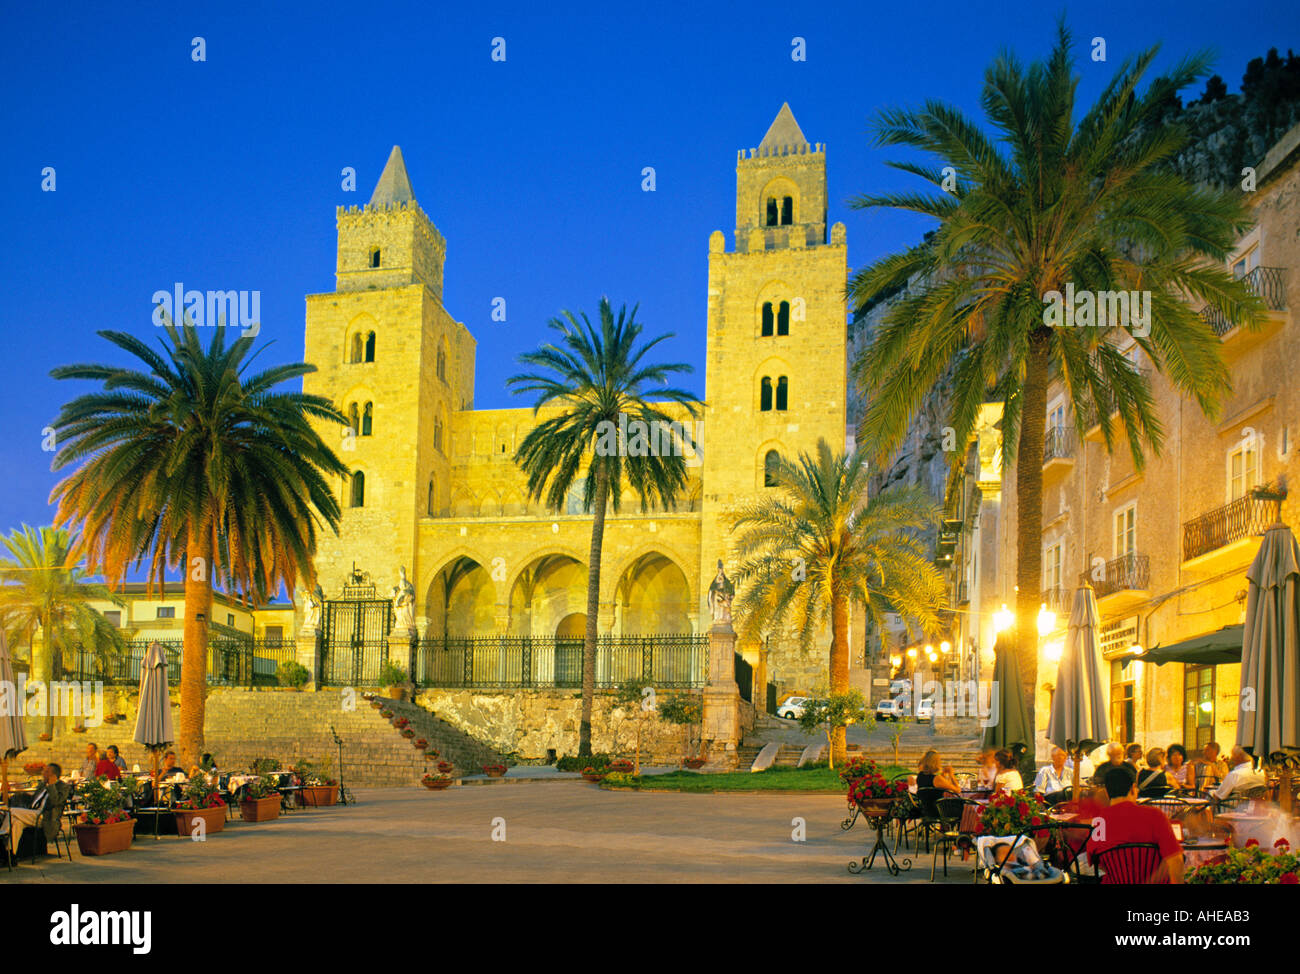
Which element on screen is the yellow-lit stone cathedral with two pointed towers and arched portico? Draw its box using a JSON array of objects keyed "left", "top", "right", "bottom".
[{"left": 299, "top": 105, "right": 863, "bottom": 696}]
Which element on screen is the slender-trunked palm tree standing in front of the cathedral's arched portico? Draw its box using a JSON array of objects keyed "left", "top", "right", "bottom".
[{"left": 507, "top": 298, "right": 697, "bottom": 757}]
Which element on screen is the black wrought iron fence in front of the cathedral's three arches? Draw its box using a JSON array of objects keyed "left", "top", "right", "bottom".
[{"left": 413, "top": 635, "right": 709, "bottom": 689}]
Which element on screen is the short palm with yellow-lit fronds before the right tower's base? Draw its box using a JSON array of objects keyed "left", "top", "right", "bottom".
[{"left": 732, "top": 440, "right": 944, "bottom": 763}]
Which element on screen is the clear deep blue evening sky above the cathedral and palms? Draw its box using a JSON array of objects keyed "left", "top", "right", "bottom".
[{"left": 0, "top": 0, "right": 1300, "bottom": 546}]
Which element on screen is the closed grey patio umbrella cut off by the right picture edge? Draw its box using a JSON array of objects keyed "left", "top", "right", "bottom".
[{"left": 1236, "top": 524, "right": 1300, "bottom": 810}]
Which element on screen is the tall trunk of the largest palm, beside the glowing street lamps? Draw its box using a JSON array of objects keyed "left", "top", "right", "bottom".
[{"left": 1015, "top": 328, "right": 1052, "bottom": 780}]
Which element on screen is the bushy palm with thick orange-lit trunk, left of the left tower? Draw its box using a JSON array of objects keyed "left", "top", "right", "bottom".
[{"left": 51, "top": 321, "right": 347, "bottom": 766}]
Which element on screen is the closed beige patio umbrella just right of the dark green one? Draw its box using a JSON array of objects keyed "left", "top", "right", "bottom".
[{"left": 1048, "top": 585, "right": 1110, "bottom": 797}]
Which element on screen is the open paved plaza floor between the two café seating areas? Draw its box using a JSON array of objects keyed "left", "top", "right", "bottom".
[{"left": 0, "top": 780, "right": 971, "bottom": 883}]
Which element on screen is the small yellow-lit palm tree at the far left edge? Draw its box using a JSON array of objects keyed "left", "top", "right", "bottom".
[{"left": 0, "top": 524, "right": 126, "bottom": 736}]
